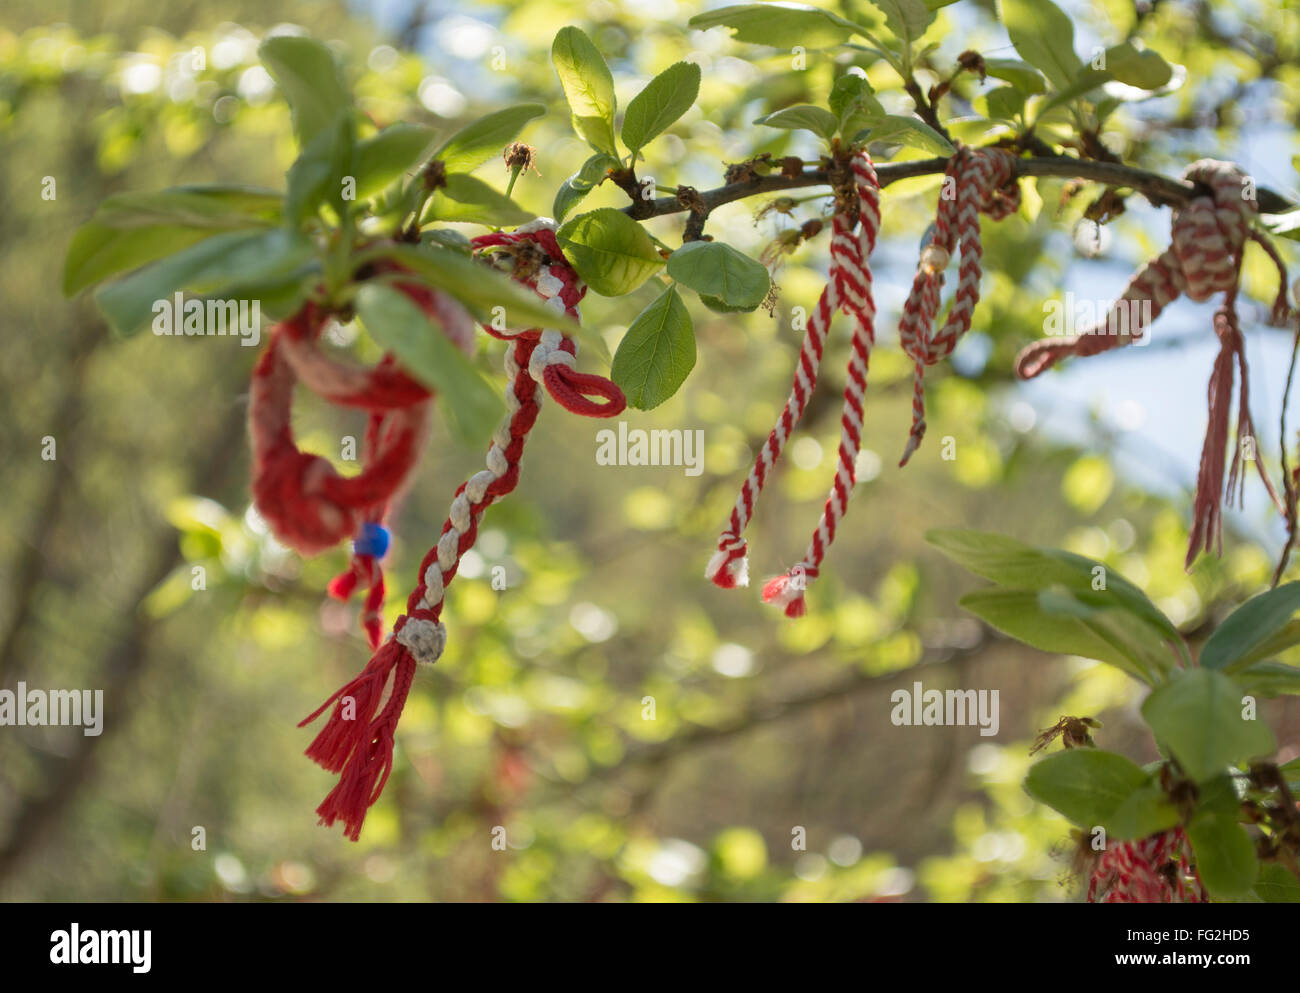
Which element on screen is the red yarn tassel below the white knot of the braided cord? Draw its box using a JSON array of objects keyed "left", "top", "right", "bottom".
[{"left": 298, "top": 638, "right": 416, "bottom": 841}]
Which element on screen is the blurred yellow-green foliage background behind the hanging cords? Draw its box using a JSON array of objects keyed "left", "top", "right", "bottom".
[{"left": 0, "top": 0, "right": 1300, "bottom": 901}]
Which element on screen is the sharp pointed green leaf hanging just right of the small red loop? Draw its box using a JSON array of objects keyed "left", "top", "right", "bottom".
[{"left": 610, "top": 286, "right": 696, "bottom": 411}]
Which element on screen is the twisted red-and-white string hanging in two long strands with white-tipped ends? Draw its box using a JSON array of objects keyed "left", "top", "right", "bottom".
[{"left": 705, "top": 152, "right": 880, "bottom": 617}]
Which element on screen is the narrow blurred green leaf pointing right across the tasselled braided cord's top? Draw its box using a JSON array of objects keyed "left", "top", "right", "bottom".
[{"left": 371, "top": 244, "right": 585, "bottom": 341}]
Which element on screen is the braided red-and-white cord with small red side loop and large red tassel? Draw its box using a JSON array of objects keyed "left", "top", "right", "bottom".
[{"left": 299, "top": 220, "right": 627, "bottom": 841}]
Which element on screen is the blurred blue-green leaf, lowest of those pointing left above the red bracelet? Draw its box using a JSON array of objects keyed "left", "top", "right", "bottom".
[{"left": 95, "top": 227, "right": 313, "bottom": 335}]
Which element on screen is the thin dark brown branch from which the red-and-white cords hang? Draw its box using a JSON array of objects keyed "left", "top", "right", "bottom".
[{"left": 624, "top": 155, "right": 1297, "bottom": 218}]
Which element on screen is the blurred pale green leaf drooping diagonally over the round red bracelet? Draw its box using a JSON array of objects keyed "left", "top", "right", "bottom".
[{"left": 356, "top": 282, "right": 506, "bottom": 446}]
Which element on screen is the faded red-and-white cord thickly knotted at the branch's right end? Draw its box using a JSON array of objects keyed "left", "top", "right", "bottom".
[{"left": 1015, "top": 159, "right": 1290, "bottom": 568}]
